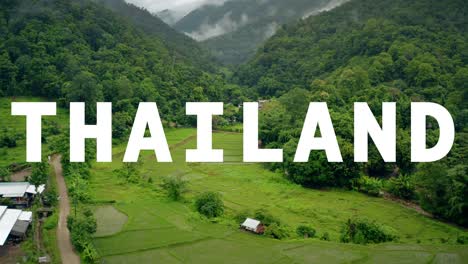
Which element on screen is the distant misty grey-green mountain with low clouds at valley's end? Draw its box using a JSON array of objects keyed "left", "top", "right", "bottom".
[{"left": 174, "top": 0, "right": 345, "bottom": 64}]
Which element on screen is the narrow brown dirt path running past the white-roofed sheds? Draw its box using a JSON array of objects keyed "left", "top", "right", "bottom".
[{"left": 51, "top": 156, "right": 80, "bottom": 264}]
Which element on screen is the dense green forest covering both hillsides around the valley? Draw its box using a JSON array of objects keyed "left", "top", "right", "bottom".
[{"left": 0, "top": 0, "right": 468, "bottom": 233}]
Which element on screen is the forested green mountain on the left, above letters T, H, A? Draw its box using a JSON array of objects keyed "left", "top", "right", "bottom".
[{"left": 0, "top": 0, "right": 247, "bottom": 126}]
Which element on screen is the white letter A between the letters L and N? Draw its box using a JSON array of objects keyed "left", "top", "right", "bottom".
[{"left": 294, "top": 103, "right": 343, "bottom": 162}]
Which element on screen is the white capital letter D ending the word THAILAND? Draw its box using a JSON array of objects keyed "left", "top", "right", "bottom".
[{"left": 411, "top": 103, "right": 455, "bottom": 162}]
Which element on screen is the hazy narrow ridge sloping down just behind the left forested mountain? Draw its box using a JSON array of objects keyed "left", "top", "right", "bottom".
[{"left": 94, "top": 0, "right": 214, "bottom": 70}]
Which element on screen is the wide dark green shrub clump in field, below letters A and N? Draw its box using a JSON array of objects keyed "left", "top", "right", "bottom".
[{"left": 341, "top": 219, "right": 398, "bottom": 244}]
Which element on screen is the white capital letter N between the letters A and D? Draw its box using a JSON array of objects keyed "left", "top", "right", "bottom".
[{"left": 354, "top": 103, "right": 396, "bottom": 162}]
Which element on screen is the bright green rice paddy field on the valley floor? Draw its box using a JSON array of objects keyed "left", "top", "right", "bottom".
[{"left": 91, "top": 129, "right": 468, "bottom": 264}]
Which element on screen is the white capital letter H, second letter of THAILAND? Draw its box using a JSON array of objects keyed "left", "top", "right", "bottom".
[{"left": 70, "top": 103, "right": 112, "bottom": 162}]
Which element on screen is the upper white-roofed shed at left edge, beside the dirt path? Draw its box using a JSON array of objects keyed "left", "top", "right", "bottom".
[{"left": 0, "top": 182, "right": 45, "bottom": 208}]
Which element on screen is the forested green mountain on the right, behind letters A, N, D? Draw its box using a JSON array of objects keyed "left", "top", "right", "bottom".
[{"left": 235, "top": 0, "right": 468, "bottom": 225}]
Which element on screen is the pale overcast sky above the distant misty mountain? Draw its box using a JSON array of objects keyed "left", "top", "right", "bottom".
[{"left": 125, "top": 0, "right": 226, "bottom": 15}]
